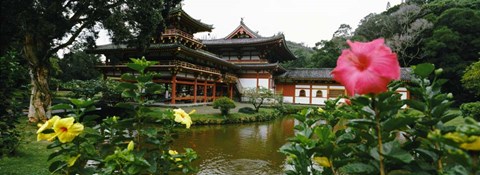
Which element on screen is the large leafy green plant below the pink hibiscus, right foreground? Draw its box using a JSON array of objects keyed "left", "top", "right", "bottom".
[{"left": 280, "top": 64, "right": 480, "bottom": 174}]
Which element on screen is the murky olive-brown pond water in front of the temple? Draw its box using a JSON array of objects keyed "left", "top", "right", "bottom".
[{"left": 173, "top": 117, "right": 294, "bottom": 175}]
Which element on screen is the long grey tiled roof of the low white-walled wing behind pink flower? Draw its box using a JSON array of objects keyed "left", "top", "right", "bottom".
[{"left": 277, "top": 68, "right": 411, "bottom": 81}]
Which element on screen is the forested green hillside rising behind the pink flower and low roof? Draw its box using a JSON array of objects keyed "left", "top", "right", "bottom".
[{"left": 284, "top": 0, "right": 480, "bottom": 103}]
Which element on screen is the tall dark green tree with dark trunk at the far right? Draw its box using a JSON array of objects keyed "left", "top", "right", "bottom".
[{"left": 421, "top": 5, "right": 480, "bottom": 104}]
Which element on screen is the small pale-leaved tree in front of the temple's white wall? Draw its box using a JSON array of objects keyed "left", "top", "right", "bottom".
[{"left": 243, "top": 87, "right": 274, "bottom": 112}]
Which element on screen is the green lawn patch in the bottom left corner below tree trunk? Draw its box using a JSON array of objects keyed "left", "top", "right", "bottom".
[{"left": 0, "top": 118, "right": 53, "bottom": 175}]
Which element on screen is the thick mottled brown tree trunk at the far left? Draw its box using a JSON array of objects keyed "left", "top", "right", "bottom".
[{"left": 24, "top": 34, "right": 52, "bottom": 122}]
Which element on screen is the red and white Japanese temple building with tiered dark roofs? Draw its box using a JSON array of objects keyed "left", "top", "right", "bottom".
[{"left": 89, "top": 7, "right": 409, "bottom": 105}]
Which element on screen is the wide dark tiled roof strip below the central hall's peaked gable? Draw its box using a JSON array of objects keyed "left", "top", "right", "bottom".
[{"left": 202, "top": 35, "right": 284, "bottom": 47}]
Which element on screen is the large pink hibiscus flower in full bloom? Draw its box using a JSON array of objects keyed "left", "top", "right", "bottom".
[{"left": 331, "top": 38, "right": 400, "bottom": 96}]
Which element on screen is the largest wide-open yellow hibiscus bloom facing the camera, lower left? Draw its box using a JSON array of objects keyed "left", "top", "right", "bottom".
[{"left": 53, "top": 117, "right": 83, "bottom": 143}]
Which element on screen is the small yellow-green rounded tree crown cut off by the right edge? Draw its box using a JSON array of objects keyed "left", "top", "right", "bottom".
[{"left": 462, "top": 61, "right": 480, "bottom": 96}]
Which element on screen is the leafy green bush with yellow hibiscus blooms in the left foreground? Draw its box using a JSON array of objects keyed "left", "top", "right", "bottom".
[{"left": 38, "top": 58, "right": 197, "bottom": 174}]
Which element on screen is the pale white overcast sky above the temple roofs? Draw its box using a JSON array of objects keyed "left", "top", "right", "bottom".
[{"left": 97, "top": 0, "right": 401, "bottom": 47}]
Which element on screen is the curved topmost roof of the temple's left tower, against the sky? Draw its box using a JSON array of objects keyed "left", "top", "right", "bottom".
[{"left": 170, "top": 7, "right": 213, "bottom": 32}]
